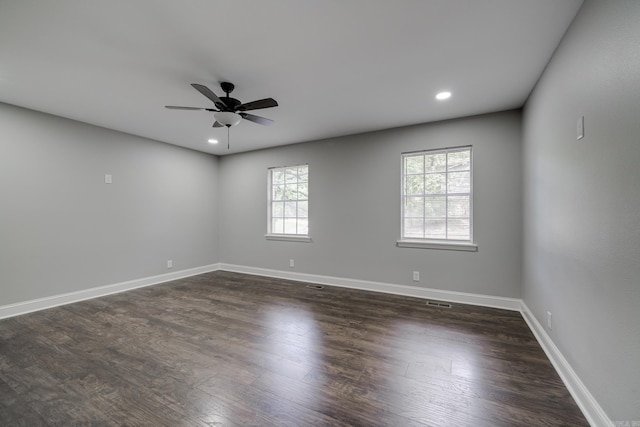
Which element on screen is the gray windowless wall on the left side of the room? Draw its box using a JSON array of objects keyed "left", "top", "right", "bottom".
[{"left": 0, "top": 104, "right": 218, "bottom": 306}]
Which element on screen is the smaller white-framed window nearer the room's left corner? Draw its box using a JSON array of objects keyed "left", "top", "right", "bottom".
[{"left": 267, "top": 165, "right": 309, "bottom": 240}]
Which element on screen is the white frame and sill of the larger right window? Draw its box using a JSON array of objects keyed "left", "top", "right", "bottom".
[{"left": 397, "top": 146, "right": 478, "bottom": 251}]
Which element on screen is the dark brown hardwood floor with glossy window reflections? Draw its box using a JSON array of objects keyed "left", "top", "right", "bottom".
[{"left": 0, "top": 272, "right": 588, "bottom": 427}]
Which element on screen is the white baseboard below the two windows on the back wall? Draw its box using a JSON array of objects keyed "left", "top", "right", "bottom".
[{"left": 220, "top": 263, "right": 520, "bottom": 311}]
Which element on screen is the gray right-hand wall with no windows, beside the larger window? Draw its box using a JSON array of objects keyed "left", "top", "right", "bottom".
[{"left": 523, "top": 0, "right": 640, "bottom": 421}]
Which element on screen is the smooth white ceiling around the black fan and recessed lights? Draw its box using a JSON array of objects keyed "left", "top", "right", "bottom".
[{"left": 0, "top": 0, "right": 582, "bottom": 155}]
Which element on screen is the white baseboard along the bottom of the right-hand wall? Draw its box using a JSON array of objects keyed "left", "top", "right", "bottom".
[{"left": 520, "top": 301, "right": 614, "bottom": 427}]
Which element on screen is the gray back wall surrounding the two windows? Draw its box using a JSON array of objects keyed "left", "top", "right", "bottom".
[{"left": 220, "top": 110, "right": 522, "bottom": 298}]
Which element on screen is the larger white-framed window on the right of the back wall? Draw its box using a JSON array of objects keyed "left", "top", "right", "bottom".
[{"left": 398, "top": 147, "right": 475, "bottom": 250}]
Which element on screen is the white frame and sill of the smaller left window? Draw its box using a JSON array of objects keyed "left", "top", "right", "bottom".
[{"left": 265, "top": 163, "right": 311, "bottom": 242}]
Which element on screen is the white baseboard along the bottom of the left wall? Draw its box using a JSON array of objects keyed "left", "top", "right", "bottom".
[{"left": 0, "top": 264, "right": 219, "bottom": 319}]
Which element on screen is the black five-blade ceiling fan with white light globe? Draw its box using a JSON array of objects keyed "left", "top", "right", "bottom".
[{"left": 165, "top": 82, "right": 278, "bottom": 128}]
